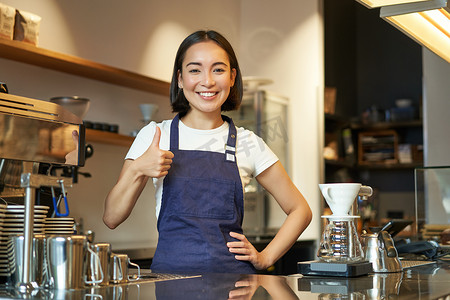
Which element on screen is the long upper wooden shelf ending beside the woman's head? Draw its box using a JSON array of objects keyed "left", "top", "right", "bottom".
[{"left": 0, "top": 38, "right": 170, "bottom": 96}]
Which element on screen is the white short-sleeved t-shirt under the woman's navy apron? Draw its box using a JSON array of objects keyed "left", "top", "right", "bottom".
[{"left": 125, "top": 120, "right": 278, "bottom": 217}]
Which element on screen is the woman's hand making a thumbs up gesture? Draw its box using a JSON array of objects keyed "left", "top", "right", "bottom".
[{"left": 135, "top": 126, "right": 174, "bottom": 178}]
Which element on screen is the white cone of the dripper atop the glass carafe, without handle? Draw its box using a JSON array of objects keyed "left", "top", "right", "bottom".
[{"left": 319, "top": 183, "right": 361, "bottom": 216}]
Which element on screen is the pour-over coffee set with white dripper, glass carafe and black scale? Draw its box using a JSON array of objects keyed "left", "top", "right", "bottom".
[{"left": 297, "top": 183, "right": 372, "bottom": 277}]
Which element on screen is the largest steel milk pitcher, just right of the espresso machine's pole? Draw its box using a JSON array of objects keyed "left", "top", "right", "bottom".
[{"left": 47, "top": 235, "right": 103, "bottom": 290}]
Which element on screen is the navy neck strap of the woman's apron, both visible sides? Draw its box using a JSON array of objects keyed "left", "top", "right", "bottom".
[{"left": 170, "top": 114, "right": 237, "bottom": 162}]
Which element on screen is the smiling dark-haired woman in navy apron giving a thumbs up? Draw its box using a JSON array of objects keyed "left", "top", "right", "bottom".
[{"left": 103, "top": 31, "right": 311, "bottom": 273}]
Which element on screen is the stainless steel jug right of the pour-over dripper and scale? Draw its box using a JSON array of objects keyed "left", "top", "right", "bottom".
[{"left": 361, "top": 230, "right": 403, "bottom": 273}]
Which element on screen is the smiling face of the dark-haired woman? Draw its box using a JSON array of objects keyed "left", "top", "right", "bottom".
[{"left": 178, "top": 41, "right": 236, "bottom": 114}]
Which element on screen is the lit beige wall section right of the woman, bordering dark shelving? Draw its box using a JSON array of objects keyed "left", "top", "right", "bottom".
[{"left": 240, "top": 0, "right": 324, "bottom": 239}]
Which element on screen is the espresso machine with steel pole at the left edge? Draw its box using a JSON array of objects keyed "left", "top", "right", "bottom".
[{"left": 0, "top": 93, "right": 85, "bottom": 293}]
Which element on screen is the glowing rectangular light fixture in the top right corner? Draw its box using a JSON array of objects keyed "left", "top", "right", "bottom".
[{"left": 380, "top": 0, "right": 450, "bottom": 63}]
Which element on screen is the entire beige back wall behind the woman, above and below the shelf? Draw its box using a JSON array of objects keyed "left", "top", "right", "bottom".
[{"left": 0, "top": 0, "right": 323, "bottom": 248}]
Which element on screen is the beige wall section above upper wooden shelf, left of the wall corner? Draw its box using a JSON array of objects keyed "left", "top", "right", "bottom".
[{"left": 2, "top": 0, "right": 240, "bottom": 81}]
